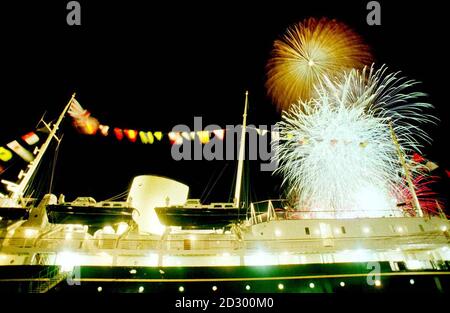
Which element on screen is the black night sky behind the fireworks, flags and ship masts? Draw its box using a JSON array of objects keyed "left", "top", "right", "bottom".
[{"left": 0, "top": 0, "right": 450, "bottom": 207}]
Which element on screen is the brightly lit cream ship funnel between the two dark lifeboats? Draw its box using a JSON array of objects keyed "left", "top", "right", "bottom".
[{"left": 127, "top": 175, "right": 189, "bottom": 234}]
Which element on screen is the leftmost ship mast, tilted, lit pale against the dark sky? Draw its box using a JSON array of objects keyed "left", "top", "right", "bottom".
[{"left": 2, "top": 93, "right": 75, "bottom": 207}]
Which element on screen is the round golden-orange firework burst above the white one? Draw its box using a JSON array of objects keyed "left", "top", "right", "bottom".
[{"left": 266, "top": 18, "right": 372, "bottom": 111}]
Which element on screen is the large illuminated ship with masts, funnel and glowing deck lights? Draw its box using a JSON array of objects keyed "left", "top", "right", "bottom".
[{"left": 0, "top": 94, "right": 450, "bottom": 295}]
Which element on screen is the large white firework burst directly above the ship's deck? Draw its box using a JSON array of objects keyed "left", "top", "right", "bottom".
[{"left": 274, "top": 67, "right": 435, "bottom": 217}]
